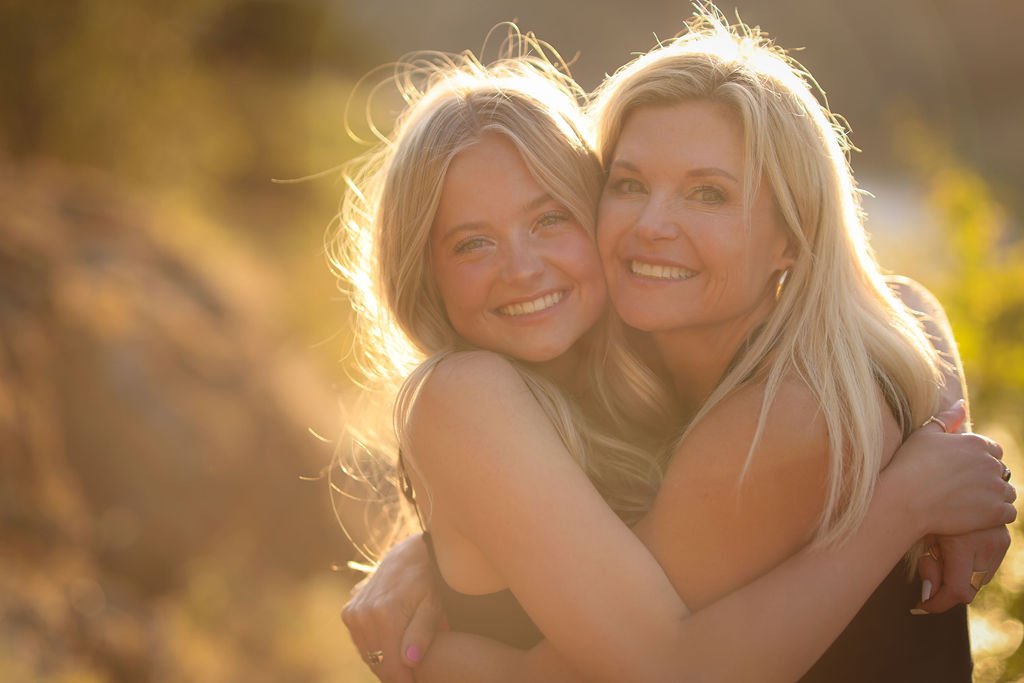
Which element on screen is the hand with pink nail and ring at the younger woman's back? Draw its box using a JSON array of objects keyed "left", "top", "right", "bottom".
[{"left": 341, "top": 533, "right": 441, "bottom": 683}]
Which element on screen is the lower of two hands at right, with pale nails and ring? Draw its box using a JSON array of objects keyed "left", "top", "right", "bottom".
[{"left": 918, "top": 526, "right": 1010, "bottom": 613}]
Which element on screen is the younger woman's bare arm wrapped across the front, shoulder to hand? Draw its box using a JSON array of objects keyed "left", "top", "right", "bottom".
[{"left": 342, "top": 124, "right": 1012, "bottom": 680}]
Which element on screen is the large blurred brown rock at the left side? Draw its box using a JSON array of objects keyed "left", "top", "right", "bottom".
[{"left": 0, "top": 158, "right": 347, "bottom": 681}]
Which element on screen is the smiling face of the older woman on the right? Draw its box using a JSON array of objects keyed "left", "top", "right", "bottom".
[{"left": 598, "top": 101, "right": 793, "bottom": 332}]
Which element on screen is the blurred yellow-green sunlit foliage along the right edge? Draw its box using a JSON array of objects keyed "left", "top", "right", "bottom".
[{"left": 881, "top": 115, "right": 1024, "bottom": 683}]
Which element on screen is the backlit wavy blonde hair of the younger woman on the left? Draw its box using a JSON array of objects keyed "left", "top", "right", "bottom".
[{"left": 331, "top": 32, "right": 671, "bottom": 557}]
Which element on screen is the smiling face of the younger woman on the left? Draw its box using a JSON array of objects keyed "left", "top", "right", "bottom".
[{"left": 430, "top": 133, "right": 606, "bottom": 362}]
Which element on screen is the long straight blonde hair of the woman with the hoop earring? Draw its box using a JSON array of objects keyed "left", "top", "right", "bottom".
[{"left": 591, "top": 8, "right": 942, "bottom": 543}]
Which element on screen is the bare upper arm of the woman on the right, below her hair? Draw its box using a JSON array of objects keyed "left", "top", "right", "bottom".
[{"left": 638, "top": 376, "right": 829, "bottom": 608}]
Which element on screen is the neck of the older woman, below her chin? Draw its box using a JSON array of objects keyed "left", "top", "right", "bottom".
[{"left": 651, "top": 300, "right": 775, "bottom": 415}]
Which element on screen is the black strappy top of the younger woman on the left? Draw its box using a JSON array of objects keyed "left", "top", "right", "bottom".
[{"left": 423, "top": 531, "right": 544, "bottom": 650}]
